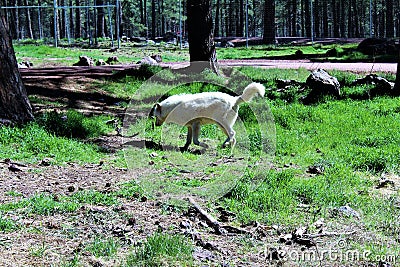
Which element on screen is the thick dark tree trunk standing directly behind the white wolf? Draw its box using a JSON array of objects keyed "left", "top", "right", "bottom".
[{"left": 187, "top": 0, "right": 217, "bottom": 72}]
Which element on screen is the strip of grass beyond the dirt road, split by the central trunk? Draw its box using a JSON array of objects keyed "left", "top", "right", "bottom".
[{"left": 14, "top": 41, "right": 382, "bottom": 67}]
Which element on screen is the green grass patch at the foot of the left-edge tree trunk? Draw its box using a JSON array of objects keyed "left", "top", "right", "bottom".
[{"left": 0, "top": 111, "right": 112, "bottom": 164}]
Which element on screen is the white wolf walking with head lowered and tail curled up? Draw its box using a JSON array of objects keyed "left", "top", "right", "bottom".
[{"left": 150, "top": 83, "right": 265, "bottom": 151}]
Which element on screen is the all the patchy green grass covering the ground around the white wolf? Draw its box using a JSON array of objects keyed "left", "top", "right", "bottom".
[{"left": 0, "top": 46, "right": 400, "bottom": 266}]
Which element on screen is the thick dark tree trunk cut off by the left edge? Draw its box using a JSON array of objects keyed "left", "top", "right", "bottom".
[{"left": 0, "top": 10, "right": 33, "bottom": 124}]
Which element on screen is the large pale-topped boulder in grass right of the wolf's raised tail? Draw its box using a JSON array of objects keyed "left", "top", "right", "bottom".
[{"left": 306, "top": 69, "right": 340, "bottom": 96}]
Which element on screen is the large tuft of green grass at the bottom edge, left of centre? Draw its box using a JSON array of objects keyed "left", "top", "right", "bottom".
[{"left": 123, "top": 233, "right": 194, "bottom": 267}]
